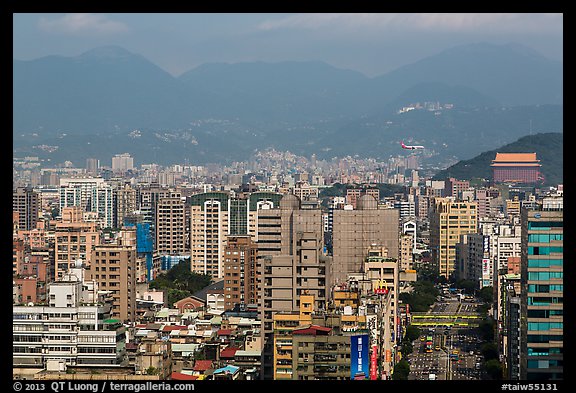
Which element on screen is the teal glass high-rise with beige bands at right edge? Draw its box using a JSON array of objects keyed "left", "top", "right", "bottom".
[{"left": 520, "top": 197, "right": 564, "bottom": 380}]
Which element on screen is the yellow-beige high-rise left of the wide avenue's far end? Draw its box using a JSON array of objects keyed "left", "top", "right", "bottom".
[{"left": 428, "top": 198, "right": 478, "bottom": 278}]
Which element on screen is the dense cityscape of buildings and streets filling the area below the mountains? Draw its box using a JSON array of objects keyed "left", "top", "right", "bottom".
[{"left": 12, "top": 145, "right": 563, "bottom": 380}]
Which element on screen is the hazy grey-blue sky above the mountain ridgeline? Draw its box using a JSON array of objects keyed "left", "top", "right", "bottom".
[{"left": 13, "top": 13, "right": 563, "bottom": 76}]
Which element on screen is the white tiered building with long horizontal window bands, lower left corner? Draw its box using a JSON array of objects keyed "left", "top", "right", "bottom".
[{"left": 12, "top": 261, "right": 126, "bottom": 378}]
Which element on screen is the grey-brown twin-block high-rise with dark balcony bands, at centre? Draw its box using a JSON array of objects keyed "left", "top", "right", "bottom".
[{"left": 257, "top": 194, "right": 329, "bottom": 379}]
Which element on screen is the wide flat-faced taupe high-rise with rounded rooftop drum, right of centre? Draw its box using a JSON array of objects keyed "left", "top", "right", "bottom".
[{"left": 329, "top": 194, "right": 400, "bottom": 287}]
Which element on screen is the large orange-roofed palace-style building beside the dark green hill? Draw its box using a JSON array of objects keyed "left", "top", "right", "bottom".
[{"left": 490, "top": 153, "right": 542, "bottom": 183}]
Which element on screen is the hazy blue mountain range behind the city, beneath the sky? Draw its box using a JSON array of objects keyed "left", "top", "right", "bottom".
[{"left": 13, "top": 43, "right": 563, "bottom": 165}]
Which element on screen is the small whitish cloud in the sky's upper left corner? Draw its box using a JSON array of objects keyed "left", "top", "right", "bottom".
[{"left": 38, "top": 14, "right": 128, "bottom": 34}]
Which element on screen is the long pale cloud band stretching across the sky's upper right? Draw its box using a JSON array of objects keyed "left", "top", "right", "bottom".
[{"left": 258, "top": 13, "right": 563, "bottom": 33}]
